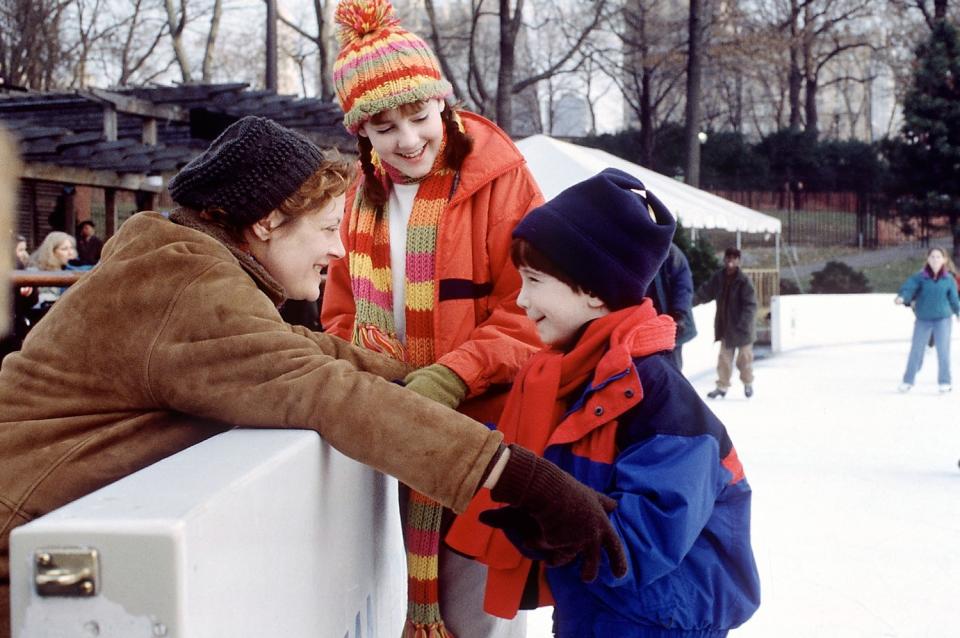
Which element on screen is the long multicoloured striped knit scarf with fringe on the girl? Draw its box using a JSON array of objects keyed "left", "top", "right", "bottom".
[{"left": 349, "top": 125, "right": 462, "bottom": 638}]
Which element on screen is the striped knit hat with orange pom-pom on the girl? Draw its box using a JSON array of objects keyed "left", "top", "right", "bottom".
[{"left": 333, "top": 0, "right": 453, "bottom": 134}]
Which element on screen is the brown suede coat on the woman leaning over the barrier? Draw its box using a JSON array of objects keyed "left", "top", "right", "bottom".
[{"left": 0, "top": 210, "right": 501, "bottom": 636}]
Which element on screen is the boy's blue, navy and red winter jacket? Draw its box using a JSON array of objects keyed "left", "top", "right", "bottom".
[{"left": 544, "top": 354, "right": 760, "bottom": 638}]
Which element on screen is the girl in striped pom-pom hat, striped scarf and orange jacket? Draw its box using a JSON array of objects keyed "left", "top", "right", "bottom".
[{"left": 321, "top": 0, "right": 543, "bottom": 638}]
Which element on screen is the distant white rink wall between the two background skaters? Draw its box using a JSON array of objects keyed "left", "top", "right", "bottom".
[{"left": 771, "top": 293, "right": 914, "bottom": 353}]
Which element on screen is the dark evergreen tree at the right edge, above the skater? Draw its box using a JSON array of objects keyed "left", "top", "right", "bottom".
[{"left": 886, "top": 19, "right": 960, "bottom": 258}]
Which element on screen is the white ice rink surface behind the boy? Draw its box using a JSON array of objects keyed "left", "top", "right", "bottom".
[{"left": 528, "top": 338, "right": 960, "bottom": 638}]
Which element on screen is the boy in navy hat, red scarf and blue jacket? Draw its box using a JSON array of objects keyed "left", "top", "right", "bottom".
[{"left": 462, "top": 169, "right": 760, "bottom": 638}]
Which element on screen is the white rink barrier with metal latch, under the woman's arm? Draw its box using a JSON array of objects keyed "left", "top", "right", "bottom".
[{"left": 10, "top": 429, "right": 406, "bottom": 638}]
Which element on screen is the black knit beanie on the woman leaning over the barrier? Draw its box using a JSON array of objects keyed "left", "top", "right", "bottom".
[{"left": 167, "top": 115, "right": 323, "bottom": 228}]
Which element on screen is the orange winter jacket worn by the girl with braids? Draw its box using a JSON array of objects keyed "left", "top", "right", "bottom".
[{"left": 320, "top": 111, "right": 543, "bottom": 421}]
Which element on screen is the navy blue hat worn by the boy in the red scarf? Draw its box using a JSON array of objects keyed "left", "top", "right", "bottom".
[{"left": 513, "top": 168, "right": 676, "bottom": 310}]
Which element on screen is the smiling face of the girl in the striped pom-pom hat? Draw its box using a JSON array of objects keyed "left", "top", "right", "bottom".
[{"left": 360, "top": 99, "right": 445, "bottom": 179}]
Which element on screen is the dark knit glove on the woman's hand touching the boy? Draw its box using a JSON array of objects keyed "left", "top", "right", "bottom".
[{"left": 480, "top": 445, "right": 627, "bottom": 582}]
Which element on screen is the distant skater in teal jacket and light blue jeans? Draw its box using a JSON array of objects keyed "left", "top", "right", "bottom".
[{"left": 893, "top": 247, "right": 960, "bottom": 393}]
